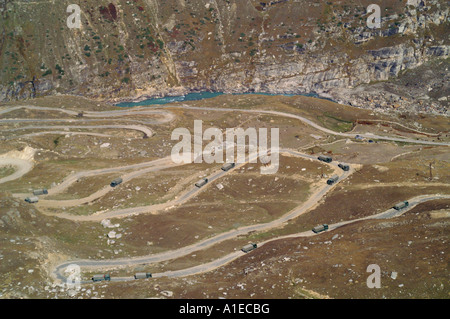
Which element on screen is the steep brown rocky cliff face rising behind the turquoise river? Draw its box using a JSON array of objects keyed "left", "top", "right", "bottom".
[{"left": 0, "top": 0, "right": 449, "bottom": 109}]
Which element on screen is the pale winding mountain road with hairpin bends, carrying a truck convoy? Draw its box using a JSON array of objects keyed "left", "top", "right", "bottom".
[{"left": 0, "top": 105, "right": 450, "bottom": 281}]
